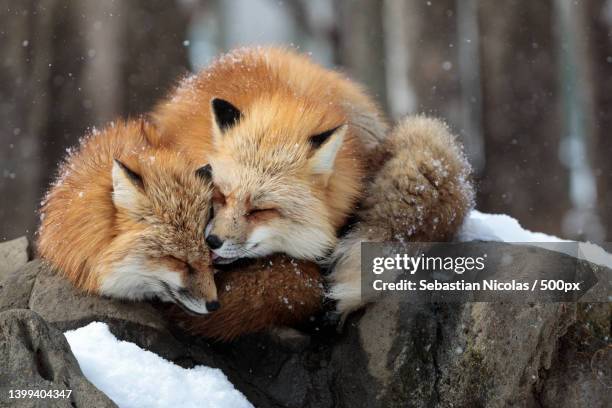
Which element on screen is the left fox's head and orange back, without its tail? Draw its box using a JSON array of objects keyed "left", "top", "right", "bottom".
[{"left": 38, "top": 121, "right": 219, "bottom": 314}]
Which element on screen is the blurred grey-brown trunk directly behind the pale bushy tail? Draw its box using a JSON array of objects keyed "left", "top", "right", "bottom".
[{"left": 400, "top": 0, "right": 483, "bottom": 170}]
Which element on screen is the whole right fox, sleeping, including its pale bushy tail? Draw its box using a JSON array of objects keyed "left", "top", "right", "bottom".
[{"left": 153, "top": 48, "right": 473, "bottom": 314}]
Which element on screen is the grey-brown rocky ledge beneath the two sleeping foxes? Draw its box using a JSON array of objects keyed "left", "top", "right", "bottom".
[{"left": 0, "top": 239, "right": 612, "bottom": 408}]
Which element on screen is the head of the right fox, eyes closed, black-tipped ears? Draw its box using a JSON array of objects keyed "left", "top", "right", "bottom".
[{"left": 206, "top": 95, "right": 348, "bottom": 262}]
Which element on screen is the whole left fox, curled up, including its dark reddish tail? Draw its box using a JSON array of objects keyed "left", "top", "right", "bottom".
[{"left": 37, "top": 121, "right": 323, "bottom": 340}]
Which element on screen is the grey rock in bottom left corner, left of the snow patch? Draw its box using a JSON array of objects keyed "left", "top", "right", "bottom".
[{"left": 0, "top": 310, "right": 116, "bottom": 408}]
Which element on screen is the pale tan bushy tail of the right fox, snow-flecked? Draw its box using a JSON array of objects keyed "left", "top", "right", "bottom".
[{"left": 328, "top": 116, "right": 474, "bottom": 315}]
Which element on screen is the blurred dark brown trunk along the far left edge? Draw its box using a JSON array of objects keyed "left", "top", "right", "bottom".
[{"left": 0, "top": 0, "right": 58, "bottom": 241}]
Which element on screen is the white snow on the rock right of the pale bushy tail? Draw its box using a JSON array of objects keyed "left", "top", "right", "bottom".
[{"left": 457, "top": 210, "right": 612, "bottom": 268}]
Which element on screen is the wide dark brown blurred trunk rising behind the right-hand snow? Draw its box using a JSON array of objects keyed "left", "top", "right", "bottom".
[{"left": 478, "top": 0, "right": 570, "bottom": 234}]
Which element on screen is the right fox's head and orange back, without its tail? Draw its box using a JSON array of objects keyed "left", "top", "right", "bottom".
[{"left": 153, "top": 48, "right": 386, "bottom": 261}]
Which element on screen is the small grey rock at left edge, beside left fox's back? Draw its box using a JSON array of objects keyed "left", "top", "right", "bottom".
[{"left": 0, "top": 260, "right": 42, "bottom": 312}]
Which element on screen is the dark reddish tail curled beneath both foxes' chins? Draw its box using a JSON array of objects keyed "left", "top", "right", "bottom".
[{"left": 171, "top": 255, "right": 323, "bottom": 341}]
